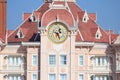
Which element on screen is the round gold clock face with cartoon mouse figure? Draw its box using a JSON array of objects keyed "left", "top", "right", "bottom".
[{"left": 48, "top": 22, "right": 68, "bottom": 43}]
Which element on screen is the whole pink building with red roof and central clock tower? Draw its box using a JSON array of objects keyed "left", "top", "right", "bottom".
[{"left": 0, "top": 0, "right": 120, "bottom": 80}]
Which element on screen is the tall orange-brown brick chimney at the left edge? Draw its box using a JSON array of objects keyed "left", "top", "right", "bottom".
[{"left": 0, "top": 0, "right": 7, "bottom": 35}]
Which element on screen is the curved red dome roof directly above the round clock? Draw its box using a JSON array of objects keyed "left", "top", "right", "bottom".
[{"left": 42, "top": 9, "right": 74, "bottom": 26}]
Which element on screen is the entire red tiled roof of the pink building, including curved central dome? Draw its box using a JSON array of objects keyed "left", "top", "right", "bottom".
[{"left": 8, "top": 2, "right": 117, "bottom": 42}]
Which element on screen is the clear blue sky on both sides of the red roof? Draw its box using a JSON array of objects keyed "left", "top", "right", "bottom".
[{"left": 7, "top": 0, "right": 120, "bottom": 34}]
